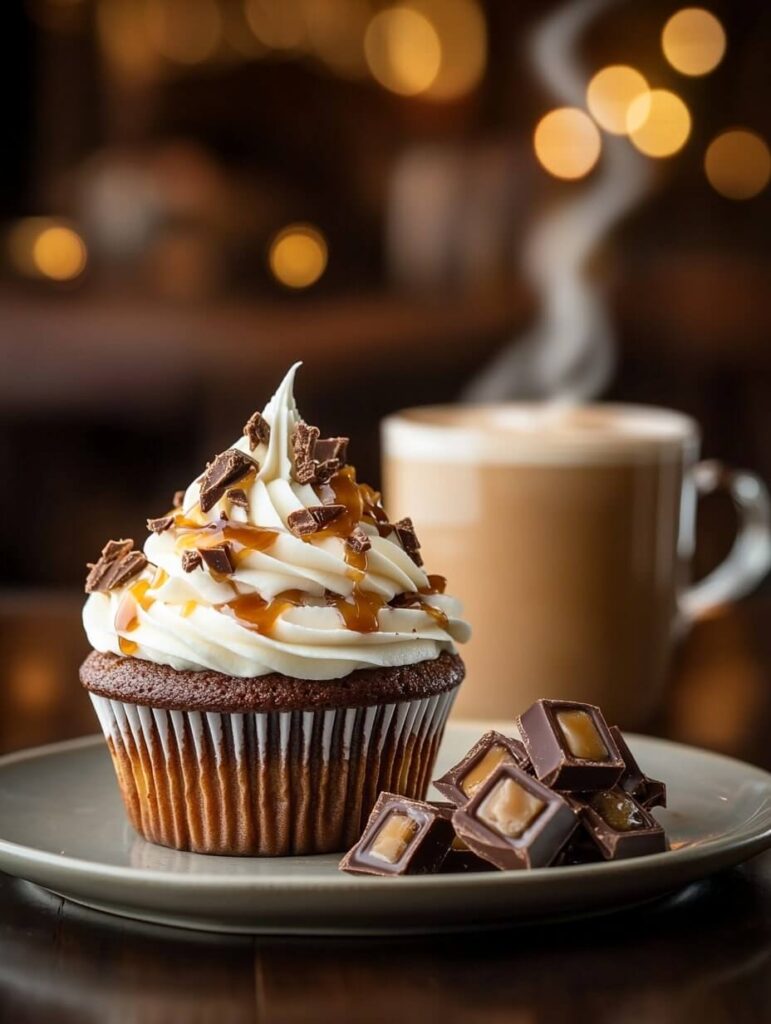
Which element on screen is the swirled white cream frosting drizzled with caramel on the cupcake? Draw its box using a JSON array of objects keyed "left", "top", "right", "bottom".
[{"left": 83, "top": 364, "right": 470, "bottom": 680}]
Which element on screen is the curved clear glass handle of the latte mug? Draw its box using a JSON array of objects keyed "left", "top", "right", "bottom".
[{"left": 680, "top": 460, "right": 771, "bottom": 622}]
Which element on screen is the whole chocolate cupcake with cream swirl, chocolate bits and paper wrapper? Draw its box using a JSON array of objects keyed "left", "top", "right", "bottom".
[{"left": 80, "top": 366, "right": 469, "bottom": 856}]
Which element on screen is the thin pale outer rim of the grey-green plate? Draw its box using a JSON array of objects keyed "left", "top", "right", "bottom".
[{"left": 0, "top": 720, "right": 771, "bottom": 892}]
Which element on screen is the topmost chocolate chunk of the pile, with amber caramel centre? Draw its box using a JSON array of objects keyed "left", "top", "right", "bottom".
[{"left": 518, "top": 700, "right": 625, "bottom": 791}]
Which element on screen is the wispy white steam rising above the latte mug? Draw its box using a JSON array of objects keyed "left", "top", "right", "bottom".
[{"left": 464, "top": 0, "right": 651, "bottom": 403}]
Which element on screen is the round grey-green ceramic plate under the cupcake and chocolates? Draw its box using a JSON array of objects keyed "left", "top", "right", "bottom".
[{"left": 0, "top": 723, "right": 771, "bottom": 934}]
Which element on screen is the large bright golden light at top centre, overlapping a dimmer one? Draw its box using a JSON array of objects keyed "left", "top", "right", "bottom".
[{"left": 365, "top": 7, "right": 441, "bottom": 96}]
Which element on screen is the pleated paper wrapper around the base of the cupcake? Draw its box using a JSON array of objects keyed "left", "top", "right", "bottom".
[{"left": 91, "top": 687, "right": 457, "bottom": 857}]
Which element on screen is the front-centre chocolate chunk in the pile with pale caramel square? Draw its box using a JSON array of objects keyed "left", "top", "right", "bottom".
[{"left": 453, "top": 762, "right": 579, "bottom": 870}]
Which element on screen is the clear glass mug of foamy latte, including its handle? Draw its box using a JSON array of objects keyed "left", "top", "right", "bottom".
[{"left": 382, "top": 403, "right": 771, "bottom": 728}]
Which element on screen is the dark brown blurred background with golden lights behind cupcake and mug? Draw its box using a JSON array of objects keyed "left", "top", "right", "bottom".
[{"left": 0, "top": 0, "right": 771, "bottom": 761}]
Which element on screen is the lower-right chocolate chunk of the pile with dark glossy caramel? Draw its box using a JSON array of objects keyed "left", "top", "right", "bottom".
[{"left": 572, "top": 786, "right": 668, "bottom": 860}]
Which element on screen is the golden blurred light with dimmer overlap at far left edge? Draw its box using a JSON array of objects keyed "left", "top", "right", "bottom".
[{"left": 7, "top": 217, "right": 88, "bottom": 281}]
